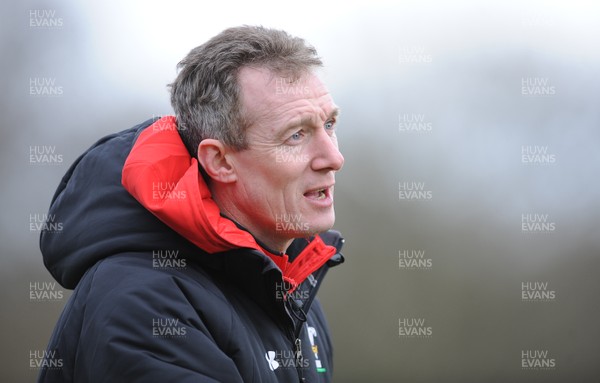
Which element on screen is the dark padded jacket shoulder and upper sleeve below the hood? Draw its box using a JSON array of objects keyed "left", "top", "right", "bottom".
[{"left": 48, "top": 254, "right": 242, "bottom": 382}]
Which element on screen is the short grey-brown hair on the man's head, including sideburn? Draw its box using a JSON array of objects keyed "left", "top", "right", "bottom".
[{"left": 170, "top": 26, "right": 323, "bottom": 157}]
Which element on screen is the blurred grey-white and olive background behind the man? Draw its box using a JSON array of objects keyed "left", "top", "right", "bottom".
[{"left": 0, "top": 0, "right": 600, "bottom": 383}]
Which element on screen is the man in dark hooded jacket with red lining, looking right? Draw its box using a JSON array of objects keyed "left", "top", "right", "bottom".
[{"left": 39, "top": 27, "right": 344, "bottom": 383}]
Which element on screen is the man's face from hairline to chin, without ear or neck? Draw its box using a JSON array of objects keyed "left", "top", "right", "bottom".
[{"left": 231, "top": 68, "right": 344, "bottom": 249}]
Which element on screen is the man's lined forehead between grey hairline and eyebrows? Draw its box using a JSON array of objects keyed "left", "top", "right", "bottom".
[{"left": 238, "top": 67, "right": 337, "bottom": 130}]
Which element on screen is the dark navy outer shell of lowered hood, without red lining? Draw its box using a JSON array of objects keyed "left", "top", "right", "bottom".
[{"left": 40, "top": 120, "right": 193, "bottom": 289}]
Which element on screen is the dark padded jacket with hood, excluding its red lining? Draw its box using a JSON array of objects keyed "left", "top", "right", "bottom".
[{"left": 39, "top": 121, "right": 343, "bottom": 383}]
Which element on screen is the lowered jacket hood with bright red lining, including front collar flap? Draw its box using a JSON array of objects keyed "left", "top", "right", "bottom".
[{"left": 40, "top": 117, "right": 336, "bottom": 289}]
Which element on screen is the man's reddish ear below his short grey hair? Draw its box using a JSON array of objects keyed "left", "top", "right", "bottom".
[{"left": 198, "top": 138, "right": 237, "bottom": 183}]
